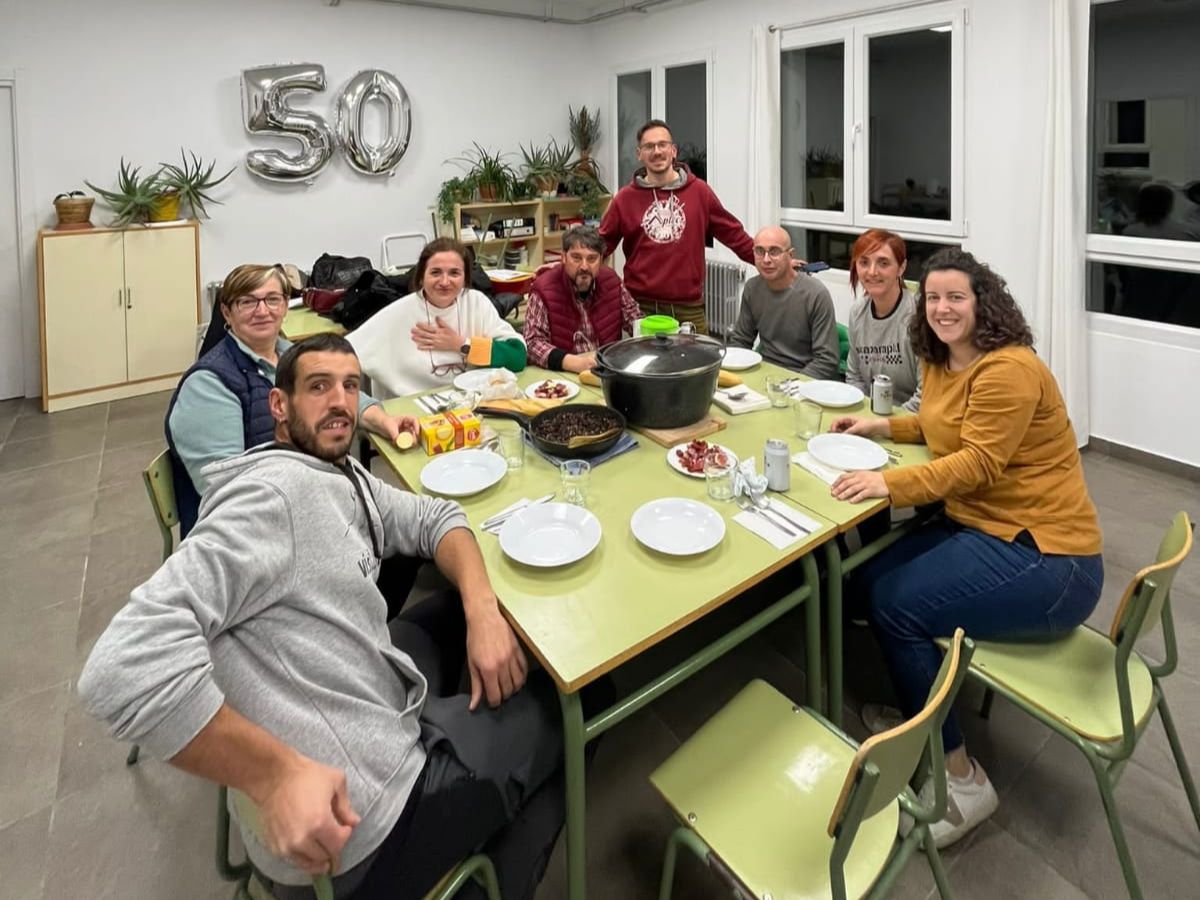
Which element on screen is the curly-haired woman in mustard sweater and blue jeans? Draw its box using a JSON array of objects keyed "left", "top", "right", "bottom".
[{"left": 833, "top": 248, "right": 1104, "bottom": 847}]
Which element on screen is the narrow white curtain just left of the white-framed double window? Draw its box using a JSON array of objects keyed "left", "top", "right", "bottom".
[{"left": 745, "top": 25, "right": 780, "bottom": 234}]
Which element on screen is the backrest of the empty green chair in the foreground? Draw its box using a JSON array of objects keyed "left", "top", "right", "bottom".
[{"left": 828, "top": 629, "right": 974, "bottom": 840}]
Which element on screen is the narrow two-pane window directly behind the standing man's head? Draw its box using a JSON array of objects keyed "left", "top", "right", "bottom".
[{"left": 612, "top": 59, "right": 712, "bottom": 191}]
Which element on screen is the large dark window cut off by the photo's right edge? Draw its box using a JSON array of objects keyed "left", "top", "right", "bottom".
[{"left": 1087, "top": 0, "right": 1200, "bottom": 328}]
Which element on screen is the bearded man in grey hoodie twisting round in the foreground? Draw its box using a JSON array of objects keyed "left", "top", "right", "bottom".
[{"left": 79, "top": 335, "right": 563, "bottom": 899}]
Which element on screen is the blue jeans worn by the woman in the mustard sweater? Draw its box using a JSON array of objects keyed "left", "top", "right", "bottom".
[{"left": 854, "top": 518, "right": 1104, "bottom": 752}]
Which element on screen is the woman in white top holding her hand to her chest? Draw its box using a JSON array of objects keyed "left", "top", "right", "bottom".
[{"left": 347, "top": 238, "right": 526, "bottom": 397}]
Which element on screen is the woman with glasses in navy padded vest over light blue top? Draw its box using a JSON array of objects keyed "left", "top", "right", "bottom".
[{"left": 166, "top": 265, "right": 416, "bottom": 536}]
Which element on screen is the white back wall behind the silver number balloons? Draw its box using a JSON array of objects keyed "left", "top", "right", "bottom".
[{"left": 0, "top": 0, "right": 595, "bottom": 394}]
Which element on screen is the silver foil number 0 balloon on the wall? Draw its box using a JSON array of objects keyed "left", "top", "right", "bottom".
[{"left": 337, "top": 68, "right": 413, "bottom": 175}]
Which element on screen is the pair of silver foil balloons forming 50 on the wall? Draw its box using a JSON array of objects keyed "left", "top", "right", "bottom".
[{"left": 241, "top": 62, "right": 413, "bottom": 184}]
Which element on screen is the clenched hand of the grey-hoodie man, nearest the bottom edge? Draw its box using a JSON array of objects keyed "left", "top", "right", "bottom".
[{"left": 257, "top": 754, "right": 359, "bottom": 875}]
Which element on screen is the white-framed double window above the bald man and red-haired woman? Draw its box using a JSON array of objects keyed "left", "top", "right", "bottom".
[{"left": 780, "top": 4, "right": 965, "bottom": 241}]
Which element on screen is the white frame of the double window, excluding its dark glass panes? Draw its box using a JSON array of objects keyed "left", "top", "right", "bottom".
[{"left": 780, "top": 2, "right": 968, "bottom": 242}]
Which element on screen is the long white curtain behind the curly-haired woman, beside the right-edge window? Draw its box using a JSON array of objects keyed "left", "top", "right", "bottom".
[{"left": 1031, "top": 0, "right": 1091, "bottom": 446}]
